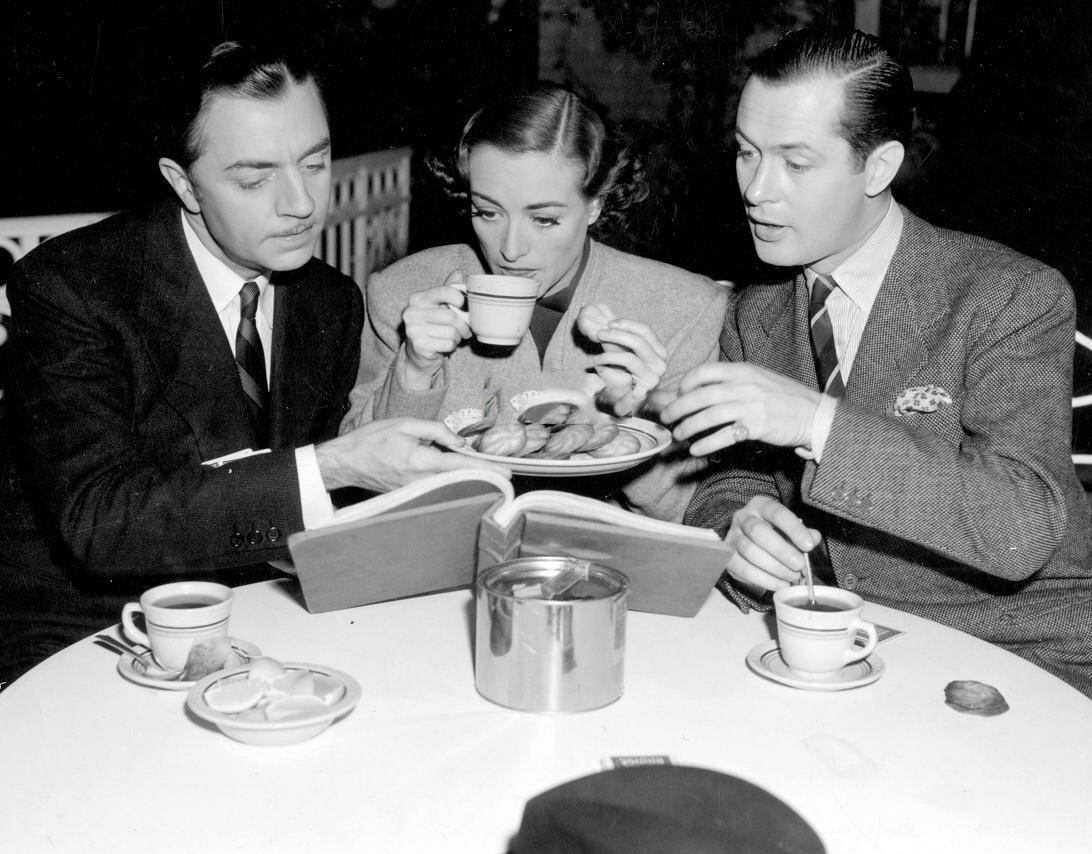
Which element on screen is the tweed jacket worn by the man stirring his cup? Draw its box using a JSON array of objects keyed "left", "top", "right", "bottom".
[{"left": 686, "top": 211, "right": 1092, "bottom": 693}]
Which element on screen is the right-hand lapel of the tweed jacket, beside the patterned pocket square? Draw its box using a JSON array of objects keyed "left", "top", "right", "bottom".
[{"left": 845, "top": 209, "right": 948, "bottom": 412}]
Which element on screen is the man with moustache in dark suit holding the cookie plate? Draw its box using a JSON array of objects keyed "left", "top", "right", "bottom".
[{"left": 0, "top": 44, "right": 495, "bottom": 684}]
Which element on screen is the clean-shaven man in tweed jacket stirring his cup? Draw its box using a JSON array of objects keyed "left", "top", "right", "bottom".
[{"left": 663, "top": 31, "right": 1092, "bottom": 695}]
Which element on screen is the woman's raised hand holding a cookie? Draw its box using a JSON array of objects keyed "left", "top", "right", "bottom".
[{"left": 577, "top": 305, "right": 667, "bottom": 416}]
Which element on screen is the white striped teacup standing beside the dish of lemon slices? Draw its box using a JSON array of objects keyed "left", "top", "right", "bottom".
[{"left": 121, "top": 581, "right": 233, "bottom": 671}]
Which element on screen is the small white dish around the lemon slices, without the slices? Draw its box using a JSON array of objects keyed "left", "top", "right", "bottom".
[{"left": 186, "top": 662, "right": 360, "bottom": 746}]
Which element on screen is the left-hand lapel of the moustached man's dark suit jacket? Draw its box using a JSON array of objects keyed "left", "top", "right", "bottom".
[{"left": 132, "top": 203, "right": 254, "bottom": 460}]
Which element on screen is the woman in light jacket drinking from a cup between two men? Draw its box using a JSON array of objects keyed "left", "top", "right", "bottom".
[{"left": 344, "top": 84, "right": 726, "bottom": 521}]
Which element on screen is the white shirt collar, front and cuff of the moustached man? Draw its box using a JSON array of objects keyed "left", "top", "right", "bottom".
[{"left": 179, "top": 214, "right": 333, "bottom": 527}]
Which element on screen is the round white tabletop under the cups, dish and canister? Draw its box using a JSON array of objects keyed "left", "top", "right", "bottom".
[{"left": 0, "top": 581, "right": 1092, "bottom": 854}]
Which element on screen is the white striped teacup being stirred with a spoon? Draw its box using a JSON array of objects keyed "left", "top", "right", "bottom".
[{"left": 773, "top": 585, "right": 877, "bottom": 679}]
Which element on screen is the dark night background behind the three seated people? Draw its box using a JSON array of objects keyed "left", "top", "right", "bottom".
[{"left": 0, "top": 0, "right": 1092, "bottom": 307}]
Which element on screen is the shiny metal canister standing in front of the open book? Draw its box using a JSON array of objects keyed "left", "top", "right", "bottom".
[{"left": 474, "top": 557, "right": 629, "bottom": 712}]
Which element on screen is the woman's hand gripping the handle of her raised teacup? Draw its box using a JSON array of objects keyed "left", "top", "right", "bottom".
[{"left": 402, "top": 270, "right": 471, "bottom": 390}]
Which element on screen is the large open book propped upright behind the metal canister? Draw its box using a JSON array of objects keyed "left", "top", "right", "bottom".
[{"left": 288, "top": 470, "right": 727, "bottom": 617}]
